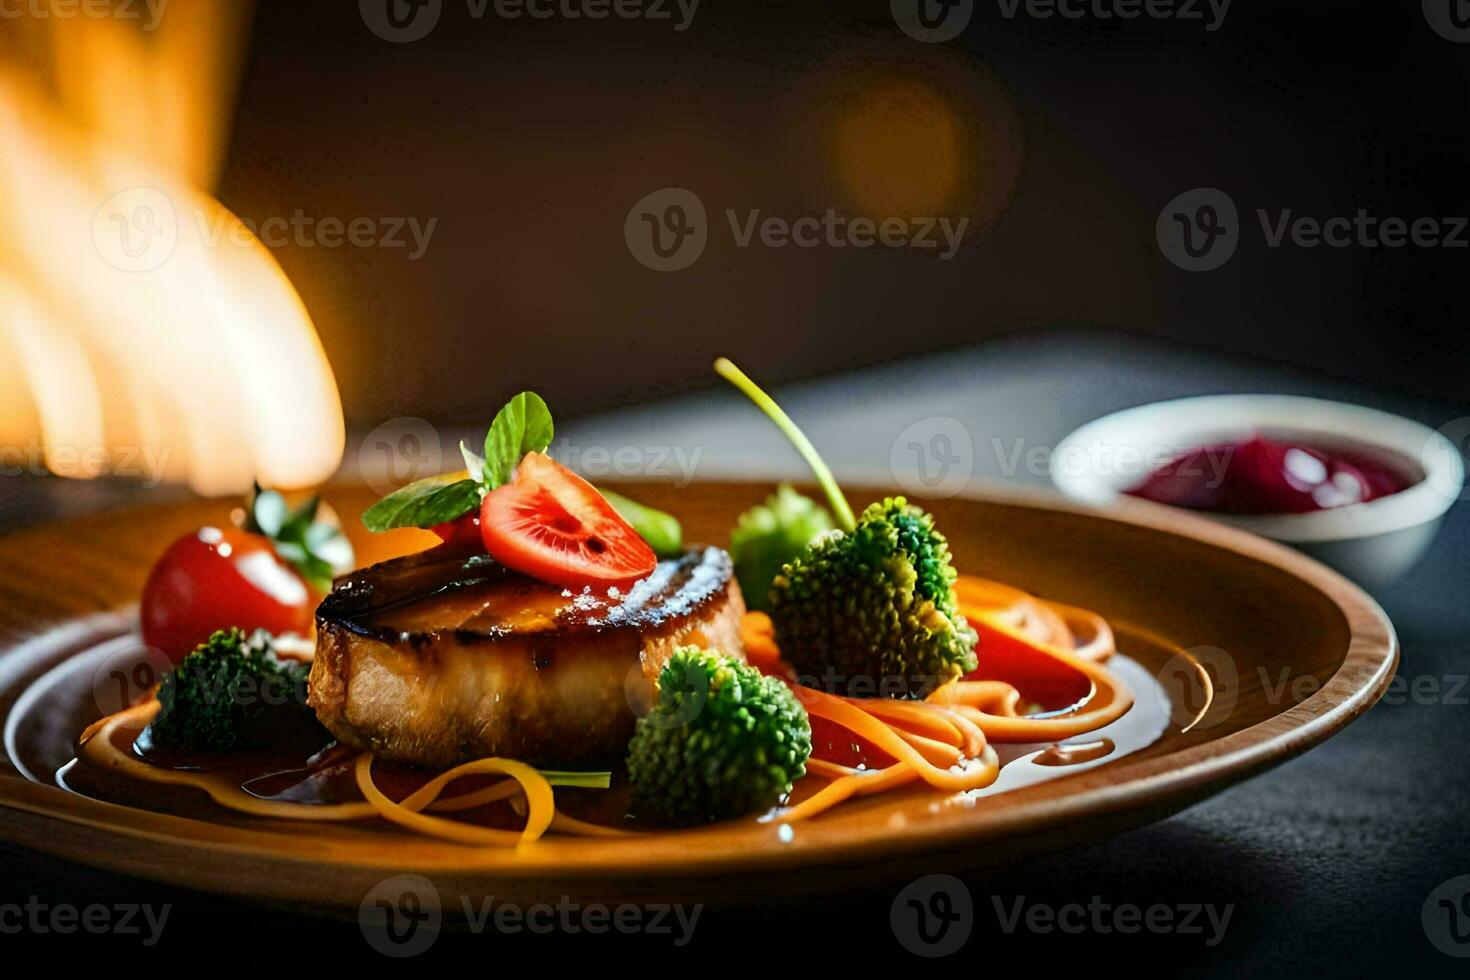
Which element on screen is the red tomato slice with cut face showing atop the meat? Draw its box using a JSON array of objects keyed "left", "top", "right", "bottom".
[{"left": 479, "top": 453, "right": 659, "bottom": 588}]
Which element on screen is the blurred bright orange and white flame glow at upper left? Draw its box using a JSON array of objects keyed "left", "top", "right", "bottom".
[{"left": 0, "top": 0, "right": 345, "bottom": 494}]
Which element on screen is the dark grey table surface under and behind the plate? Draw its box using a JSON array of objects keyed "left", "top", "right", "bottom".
[{"left": 0, "top": 334, "right": 1470, "bottom": 976}]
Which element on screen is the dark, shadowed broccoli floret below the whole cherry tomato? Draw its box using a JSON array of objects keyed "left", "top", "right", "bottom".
[{"left": 143, "top": 629, "right": 332, "bottom": 754}]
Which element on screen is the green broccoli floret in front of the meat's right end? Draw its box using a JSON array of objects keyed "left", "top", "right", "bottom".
[{"left": 628, "top": 646, "right": 811, "bottom": 826}]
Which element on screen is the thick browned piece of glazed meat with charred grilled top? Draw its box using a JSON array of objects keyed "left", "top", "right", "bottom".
[{"left": 309, "top": 548, "right": 745, "bottom": 768}]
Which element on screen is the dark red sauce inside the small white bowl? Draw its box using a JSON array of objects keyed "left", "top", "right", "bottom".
[{"left": 1127, "top": 435, "right": 1416, "bottom": 514}]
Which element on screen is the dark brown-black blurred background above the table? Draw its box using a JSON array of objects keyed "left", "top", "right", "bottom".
[{"left": 221, "top": 0, "right": 1470, "bottom": 429}]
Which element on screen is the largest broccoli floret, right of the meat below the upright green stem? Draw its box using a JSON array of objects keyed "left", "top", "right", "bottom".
[{"left": 770, "top": 497, "right": 979, "bottom": 698}]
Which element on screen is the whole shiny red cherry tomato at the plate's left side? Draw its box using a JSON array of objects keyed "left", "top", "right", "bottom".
[{"left": 140, "top": 527, "right": 313, "bottom": 663}]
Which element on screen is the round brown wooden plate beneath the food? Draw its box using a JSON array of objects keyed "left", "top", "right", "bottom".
[{"left": 0, "top": 483, "right": 1398, "bottom": 907}]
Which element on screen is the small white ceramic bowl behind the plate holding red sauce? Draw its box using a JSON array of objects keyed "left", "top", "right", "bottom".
[{"left": 1051, "top": 395, "right": 1466, "bottom": 586}]
